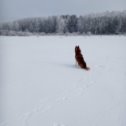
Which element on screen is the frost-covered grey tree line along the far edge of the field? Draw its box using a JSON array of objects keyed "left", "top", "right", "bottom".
[{"left": 0, "top": 11, "right": 126, "bottom": 35}]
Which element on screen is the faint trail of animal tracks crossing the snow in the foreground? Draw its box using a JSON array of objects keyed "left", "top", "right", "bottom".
[{"left": 0, "top": 79, "right": 94, "bottom": 126}]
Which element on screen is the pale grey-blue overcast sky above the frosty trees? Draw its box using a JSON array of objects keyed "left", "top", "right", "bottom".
[{"left": 0, "top": 0, "right": 126, "bottom": 22}]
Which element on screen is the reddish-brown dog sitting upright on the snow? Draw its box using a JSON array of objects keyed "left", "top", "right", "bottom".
[{"left": 75, "top": 46, "right": 90, "bottom": 70}]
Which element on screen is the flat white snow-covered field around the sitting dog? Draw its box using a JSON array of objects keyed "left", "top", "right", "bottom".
[{"left": 0, "top": 36, "right": 126, "bottom": 126}]
